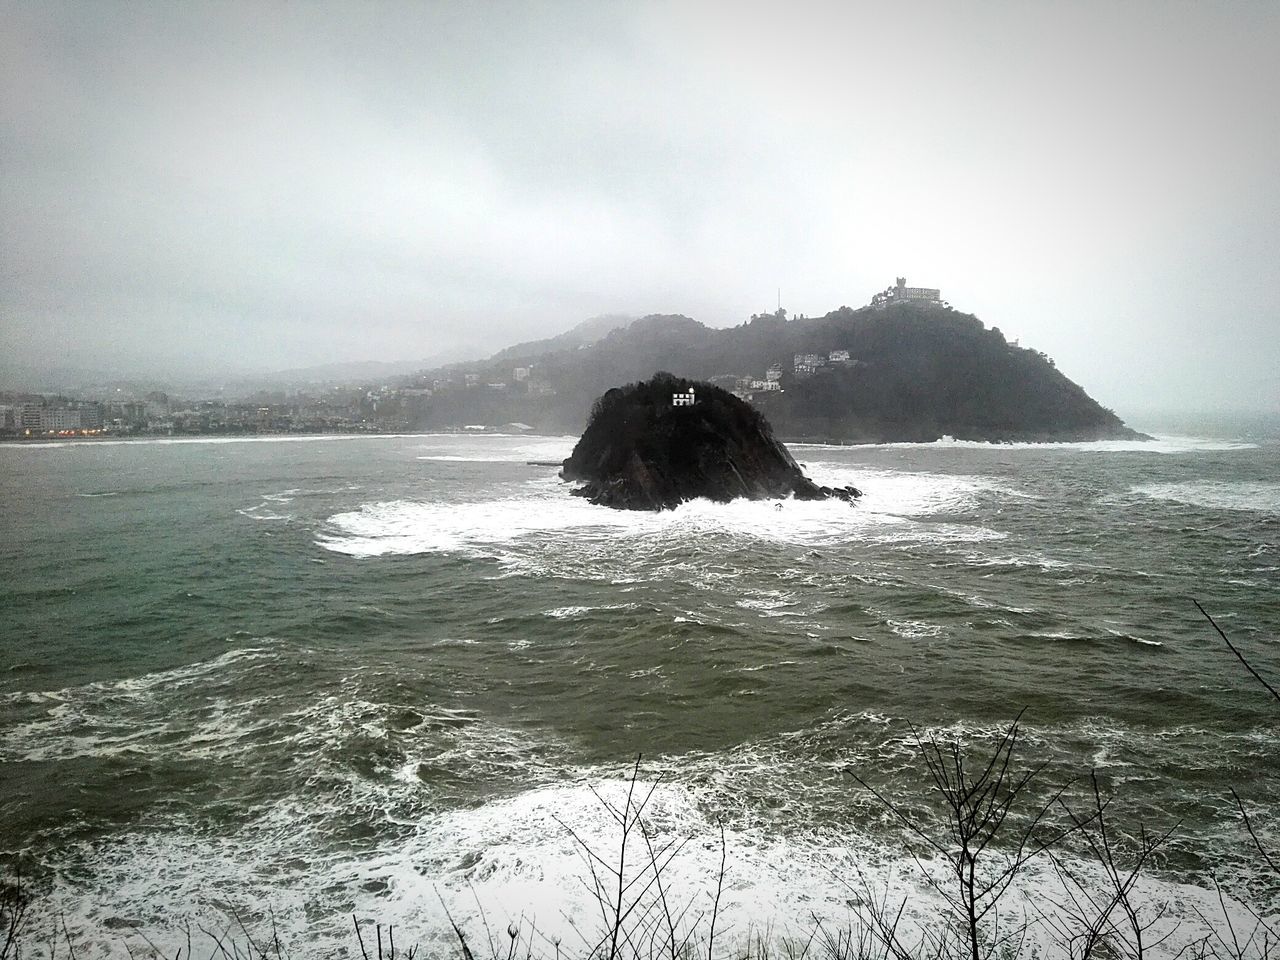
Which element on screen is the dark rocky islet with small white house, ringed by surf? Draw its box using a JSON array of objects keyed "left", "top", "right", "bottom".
[{"left": 561, "top": 372, "right": 861, "bottom": 509}]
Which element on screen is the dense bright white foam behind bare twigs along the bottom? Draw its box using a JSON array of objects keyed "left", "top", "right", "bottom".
[{"left": 35, "top": 771, "right": 1274, "bottom": 957}]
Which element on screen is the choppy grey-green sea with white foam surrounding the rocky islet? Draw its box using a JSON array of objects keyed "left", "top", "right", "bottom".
[{"left": 0, "top": 420, "right": 1280, "bottom": 957}]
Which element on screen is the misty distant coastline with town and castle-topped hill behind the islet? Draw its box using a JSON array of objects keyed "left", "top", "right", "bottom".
[{"left": 0, "top": 285, "right": 1147, "bottom": 443}]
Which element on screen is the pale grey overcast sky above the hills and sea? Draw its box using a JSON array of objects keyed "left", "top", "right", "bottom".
[{"left": 0, "top": 0, "right": 1280, "bottom": 413}]
